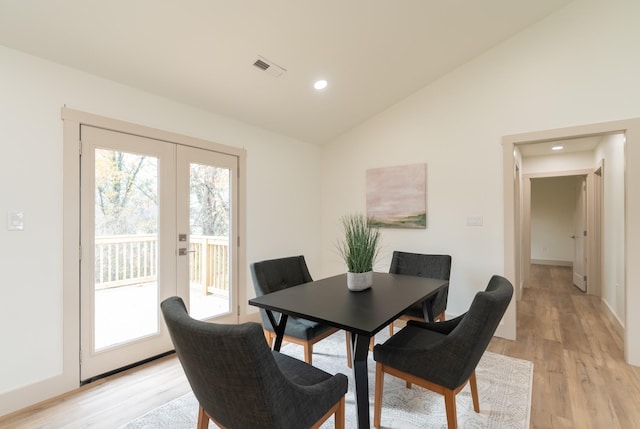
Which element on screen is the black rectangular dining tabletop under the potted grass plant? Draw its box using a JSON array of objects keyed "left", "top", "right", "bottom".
[{"left": 249, "top": 273, "right": 449, "bottom": 336}]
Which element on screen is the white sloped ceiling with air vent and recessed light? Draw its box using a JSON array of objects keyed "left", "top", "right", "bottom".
[{"left": 0, "top": 0, "right": 571, "bottom": 144}]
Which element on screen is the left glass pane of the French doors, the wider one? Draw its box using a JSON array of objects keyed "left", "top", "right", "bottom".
[{"left": 94, "top": 149, "right": 158, "bottom": 350}]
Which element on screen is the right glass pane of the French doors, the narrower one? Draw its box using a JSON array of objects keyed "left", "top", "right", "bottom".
[{"left": 189, "top": 163, "right": 231, "bottom": 319}]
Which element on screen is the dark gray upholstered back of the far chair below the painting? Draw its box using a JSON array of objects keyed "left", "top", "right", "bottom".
[{"left": 389, "top": 250, "right": 451, "bottom": 317}]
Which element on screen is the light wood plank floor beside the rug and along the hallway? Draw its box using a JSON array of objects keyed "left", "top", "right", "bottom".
[{"left": 0, "top": 265, "right": 640, "bottom": 429}]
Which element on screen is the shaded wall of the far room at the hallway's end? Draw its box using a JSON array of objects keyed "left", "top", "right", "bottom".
[{"left": 531, "top": 176, "right": 576, "bottom": 265}]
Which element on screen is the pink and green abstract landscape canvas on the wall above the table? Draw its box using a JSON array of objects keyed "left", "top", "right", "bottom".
[{"left": 367, "top": 164, "right": 427, "bottom": 228}]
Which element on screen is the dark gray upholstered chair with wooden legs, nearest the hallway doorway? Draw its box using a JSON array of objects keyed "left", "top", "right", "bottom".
[{"left": 373, "top": 276, "right": 513, "bottom": 429}]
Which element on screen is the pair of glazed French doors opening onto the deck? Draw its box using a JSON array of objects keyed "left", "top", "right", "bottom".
[{"left": 80, "top": 125, "right": 238, "bottom": 380}]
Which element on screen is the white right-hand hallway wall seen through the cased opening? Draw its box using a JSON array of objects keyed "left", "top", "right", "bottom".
[{"left": 595, "top": 134, "right": 624, "bottom": 326}]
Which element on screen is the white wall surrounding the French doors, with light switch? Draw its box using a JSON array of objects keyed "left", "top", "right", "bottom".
[{"left": 0, "top": 47, "right": 320, "bottom": 415}]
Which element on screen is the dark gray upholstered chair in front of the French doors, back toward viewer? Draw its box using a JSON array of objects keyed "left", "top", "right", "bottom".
[{"left": 161, "top": 297, "right": 348, "bottom": 429}]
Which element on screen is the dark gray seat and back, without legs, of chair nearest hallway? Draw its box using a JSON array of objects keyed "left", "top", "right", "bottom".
[{"left": 373, "top": 276, "right": 513, "bottom": 389}]
